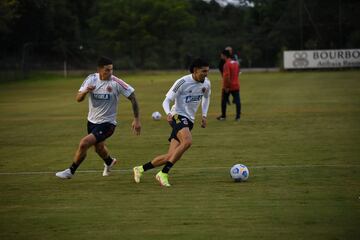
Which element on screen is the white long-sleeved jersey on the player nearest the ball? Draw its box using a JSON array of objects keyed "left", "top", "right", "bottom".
[{"left": 166, "top": 74, "right": 211, "bottom": 122}]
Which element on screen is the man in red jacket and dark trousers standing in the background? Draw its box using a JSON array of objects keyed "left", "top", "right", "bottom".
[{"left": 217, "top": 50, "right": 241, "bottom": 121}]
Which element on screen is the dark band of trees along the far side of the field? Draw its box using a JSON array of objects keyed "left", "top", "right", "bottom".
[{"left": 0, "top": 0, "right": 360, "bottom": 69}]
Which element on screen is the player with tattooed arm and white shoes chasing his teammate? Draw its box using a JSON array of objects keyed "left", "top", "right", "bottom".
[{"left": 56, "top": 57, "right": 141, "bottom": 179}]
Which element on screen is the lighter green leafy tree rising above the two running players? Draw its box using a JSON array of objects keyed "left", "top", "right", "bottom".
[{"left": 90, "top": 0, "right": 194, "bottom": 67}]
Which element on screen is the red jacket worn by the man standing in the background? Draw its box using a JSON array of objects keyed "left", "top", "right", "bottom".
[{"left": 222, "top": 58, "right": 240, "bottom": 91}]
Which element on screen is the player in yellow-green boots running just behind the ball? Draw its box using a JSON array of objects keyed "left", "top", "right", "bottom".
[{"left": 133, "top": 59, "right": 211, "bottom": 187}]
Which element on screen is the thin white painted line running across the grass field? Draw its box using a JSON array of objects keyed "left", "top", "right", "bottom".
[{"left": 0, "top": 164, "right": 360, "bottom": 176}]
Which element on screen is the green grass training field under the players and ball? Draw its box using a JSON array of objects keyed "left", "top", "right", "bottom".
[{"left": 0, "top": 71, "right": 360, "bottom": 240}]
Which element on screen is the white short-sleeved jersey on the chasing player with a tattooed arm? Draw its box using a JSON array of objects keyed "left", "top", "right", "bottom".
[{"left": 79, "top": 73, "right": 134, "bottom": 125}]
